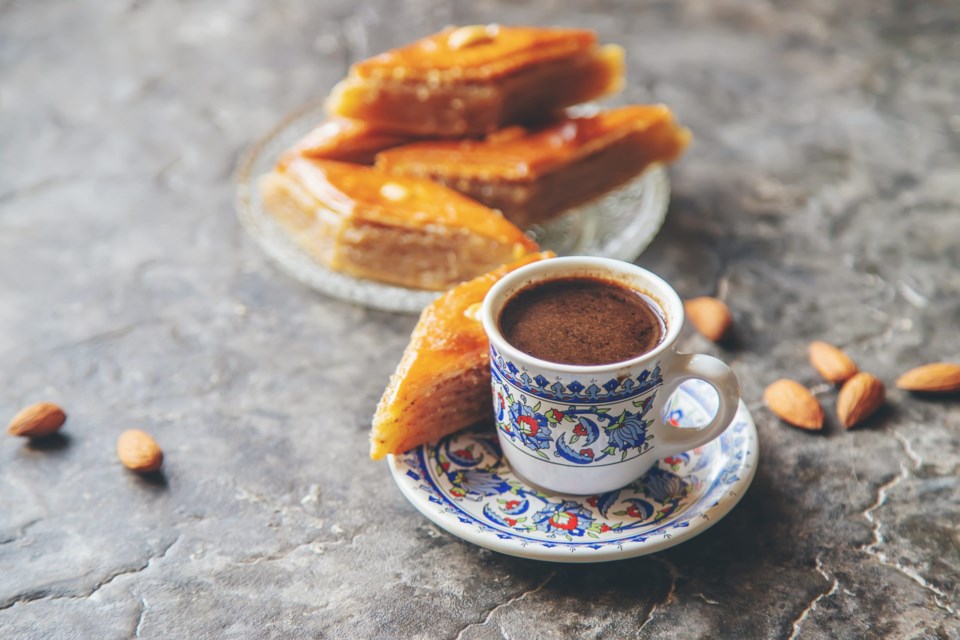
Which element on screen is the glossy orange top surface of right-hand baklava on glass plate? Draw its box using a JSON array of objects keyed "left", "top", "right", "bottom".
[{"left": 376, "top": 105, "right": 691, "bottom": 181}]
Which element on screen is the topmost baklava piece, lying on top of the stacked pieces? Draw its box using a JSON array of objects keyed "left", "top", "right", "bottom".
[{"left": 327, "top": 25, "right": 623, "bottom": 137}]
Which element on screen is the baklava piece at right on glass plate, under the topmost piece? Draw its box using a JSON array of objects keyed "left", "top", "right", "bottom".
[{"left": 377, "top": 105, "right": 691, "bottom": 228}]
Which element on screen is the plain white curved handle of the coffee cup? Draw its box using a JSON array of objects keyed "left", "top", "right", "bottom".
[{"left": 654, "top": 353, "right": 740, "bottom": 458}]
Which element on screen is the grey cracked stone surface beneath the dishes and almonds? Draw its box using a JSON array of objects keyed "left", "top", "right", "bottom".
[{"left": 0, "top": 0, "right": 960, "bottom": 639}]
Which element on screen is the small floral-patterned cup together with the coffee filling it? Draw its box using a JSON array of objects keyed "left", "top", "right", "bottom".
[{"left": 480, "top": 257, "right": 740, "bottom": 495}]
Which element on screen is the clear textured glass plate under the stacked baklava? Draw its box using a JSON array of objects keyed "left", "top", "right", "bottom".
[{"left": 235, "top": 103, "right": 670, "bottom": 313}]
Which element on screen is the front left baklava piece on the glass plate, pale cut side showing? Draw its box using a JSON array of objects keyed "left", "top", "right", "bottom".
[{"left": 260, "top": 157, "right": 537, "bottom": 291}]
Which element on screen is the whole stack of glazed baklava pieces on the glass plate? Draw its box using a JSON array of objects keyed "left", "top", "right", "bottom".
[{"left": 261, "top": 25, "right": 690, "bottom": 290}]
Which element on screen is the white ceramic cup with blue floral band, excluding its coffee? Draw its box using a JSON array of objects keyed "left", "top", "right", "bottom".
[{"left": 480, "top": 257, "right": 740, "bottom": 494}]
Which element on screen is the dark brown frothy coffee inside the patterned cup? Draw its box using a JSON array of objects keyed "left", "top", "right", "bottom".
[{"left": 499, "top": 277, "right": 666, "bottom": 365}]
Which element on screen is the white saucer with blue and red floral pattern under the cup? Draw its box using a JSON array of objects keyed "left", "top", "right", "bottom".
[{"left": 389, "top": 381, "right": 758, "bottom": 562}]
